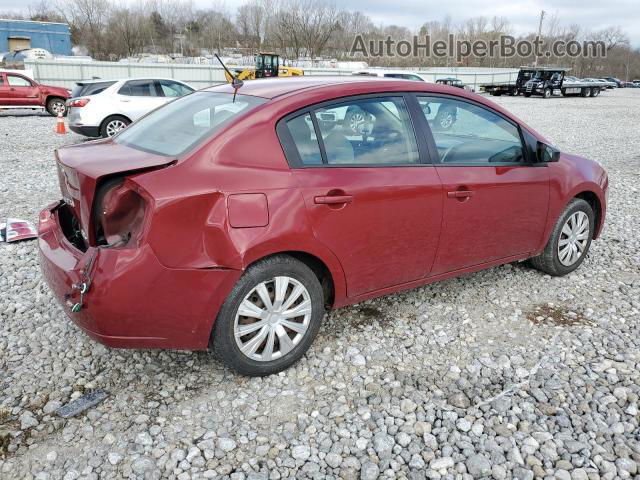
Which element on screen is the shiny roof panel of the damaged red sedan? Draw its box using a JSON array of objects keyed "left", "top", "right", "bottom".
[{"left": 201, "top": 75, "right": 426, "bottom": 98}]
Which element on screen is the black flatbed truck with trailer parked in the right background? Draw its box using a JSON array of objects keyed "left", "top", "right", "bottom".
[{"left": 481, "top": 67, "right": 606, "bottom": 98}]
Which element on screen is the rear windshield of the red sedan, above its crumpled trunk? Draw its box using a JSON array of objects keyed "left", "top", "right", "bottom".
[{"left": 115, "top": 92, "right": 267, "bottom": 157}]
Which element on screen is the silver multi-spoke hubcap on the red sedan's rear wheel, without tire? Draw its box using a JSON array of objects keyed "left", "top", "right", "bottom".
[{"left": 233, "top": 276, "right": 312, "bottom": 362}]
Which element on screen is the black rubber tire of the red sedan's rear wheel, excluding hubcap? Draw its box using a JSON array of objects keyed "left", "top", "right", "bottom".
[{"left": 210, "top": 255, "right": 325, "bottom": 376}]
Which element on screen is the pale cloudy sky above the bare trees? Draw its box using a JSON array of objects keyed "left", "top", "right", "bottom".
[{"left": 0, "top": 0, "right": 640, "bottom": 47}]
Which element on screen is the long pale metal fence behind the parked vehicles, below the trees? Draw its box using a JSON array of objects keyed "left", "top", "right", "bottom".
[{"left": 25, "top": 60, "right": 518, "bottom": 91}]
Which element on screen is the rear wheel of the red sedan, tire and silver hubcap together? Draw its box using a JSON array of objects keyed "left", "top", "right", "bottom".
[{"left": 211, "top": 255, "right": 324, "bottom": 376}]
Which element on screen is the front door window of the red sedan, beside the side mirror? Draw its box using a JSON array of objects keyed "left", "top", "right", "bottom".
[{"left": 418, "top": 96, "right": 525, "bottom": 165}]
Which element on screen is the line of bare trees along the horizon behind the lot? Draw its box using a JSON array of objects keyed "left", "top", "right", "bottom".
[{"left": 0, "top": 0, "right": 640, "bottom": 80}]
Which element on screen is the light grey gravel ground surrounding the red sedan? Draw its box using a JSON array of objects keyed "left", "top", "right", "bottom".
[{"left": 0, "top": 89, "right": 640, "bottom": 480}]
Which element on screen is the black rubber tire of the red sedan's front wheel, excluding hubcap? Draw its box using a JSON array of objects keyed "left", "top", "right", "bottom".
[{"left": 530, "top": 198, "right": 595, "bottom": 277}]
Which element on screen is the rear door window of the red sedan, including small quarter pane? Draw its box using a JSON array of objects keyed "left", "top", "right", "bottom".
[{"left": 287, "top": 97, "right": 420, "bottom": 166}]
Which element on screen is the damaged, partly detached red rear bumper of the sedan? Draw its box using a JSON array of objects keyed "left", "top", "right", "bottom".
[{"left": 38, "top": 204, "right": 241, "bottom": 350}]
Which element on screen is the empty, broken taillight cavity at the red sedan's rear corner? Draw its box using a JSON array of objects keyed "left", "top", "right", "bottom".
[{"left": 94, "top": 179, "right": 146, "bottom": 247}]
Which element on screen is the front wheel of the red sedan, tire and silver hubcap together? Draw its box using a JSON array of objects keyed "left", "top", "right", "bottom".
[{"left": 531, "top": 198, "right": 595, "bottom": 276}]
